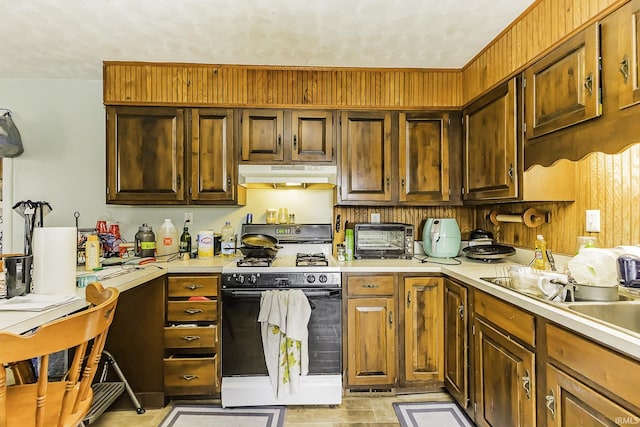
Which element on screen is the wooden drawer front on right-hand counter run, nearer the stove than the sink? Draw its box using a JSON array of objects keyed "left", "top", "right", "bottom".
[{"left": 474, "top": 292, "right": 536, "bottom": 347}]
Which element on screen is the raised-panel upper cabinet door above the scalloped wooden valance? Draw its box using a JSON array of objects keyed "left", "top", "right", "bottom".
[{"left": 524, "top": 24, "right": 602, "bottom": 139}]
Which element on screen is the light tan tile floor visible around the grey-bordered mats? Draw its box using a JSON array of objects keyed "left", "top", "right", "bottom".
[{"left": 91, "top": 391, "right": 452, "bottom": 427}]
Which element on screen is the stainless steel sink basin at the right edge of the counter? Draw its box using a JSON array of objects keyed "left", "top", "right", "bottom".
[{"left": 566, "top": 301, "right": 640, "bottom": 334}]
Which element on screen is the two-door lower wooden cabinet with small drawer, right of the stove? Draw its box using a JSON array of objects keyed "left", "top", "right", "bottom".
[{"left": 343, "top": 273, "right": 444, "bottom": 389}]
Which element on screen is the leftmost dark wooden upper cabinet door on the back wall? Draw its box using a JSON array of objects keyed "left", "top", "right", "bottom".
[{"left": 107, "top": 107, "right": 187, "bottom": 204}]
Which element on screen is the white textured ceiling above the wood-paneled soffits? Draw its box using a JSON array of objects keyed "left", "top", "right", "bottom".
[{"left": 0, "top": 0, "right": 534, "bottom": 80}]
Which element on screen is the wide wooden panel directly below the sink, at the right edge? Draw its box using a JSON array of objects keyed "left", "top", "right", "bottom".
[{"left": 546, "top": 324, "right": 640, "bottom": 405}]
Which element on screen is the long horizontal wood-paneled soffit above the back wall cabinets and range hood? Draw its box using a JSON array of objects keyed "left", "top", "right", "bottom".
[{"left": 103, "top": 62, "right": 462, "bottom": 110}]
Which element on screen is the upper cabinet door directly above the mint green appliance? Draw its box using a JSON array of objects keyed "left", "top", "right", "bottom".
[{"left": 398, "top": 113, "right": 449, "bottom": 202}]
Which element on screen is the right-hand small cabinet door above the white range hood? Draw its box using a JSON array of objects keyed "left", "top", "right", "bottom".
[{"left": 291, "top": 111, "right": 335, "bottom": 162}]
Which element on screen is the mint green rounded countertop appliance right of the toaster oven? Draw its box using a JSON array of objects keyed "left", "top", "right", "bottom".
[{"left": 422, "top": 218, "right": 461, "bottom": 258}]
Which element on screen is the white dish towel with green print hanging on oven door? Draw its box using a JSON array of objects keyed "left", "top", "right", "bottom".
[{"left": 258, "top": 289, "right": 311, "bottom": 399}]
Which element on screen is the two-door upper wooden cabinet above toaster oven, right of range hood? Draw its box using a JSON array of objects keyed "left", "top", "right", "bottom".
[{"left": 338, "top": 111, "right": 459, "bottom": 205}]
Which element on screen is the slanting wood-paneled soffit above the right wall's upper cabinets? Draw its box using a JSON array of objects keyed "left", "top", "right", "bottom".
[{"left": 462, "top": 0, "right": 628, "bottom": 104}]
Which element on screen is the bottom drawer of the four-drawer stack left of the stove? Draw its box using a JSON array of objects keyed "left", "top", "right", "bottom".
[{"left": 164, "top": 355, "right": 218, "bottom": 395}]
